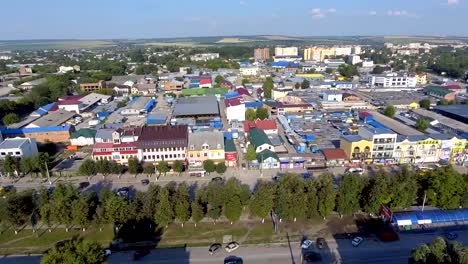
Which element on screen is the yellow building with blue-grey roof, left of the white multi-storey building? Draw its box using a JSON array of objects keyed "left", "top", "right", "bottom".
[{"left": 340, "top": 135, "right": 373, "bottom": 164}]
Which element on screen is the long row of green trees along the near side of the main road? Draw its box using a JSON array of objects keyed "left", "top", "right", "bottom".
[{"left": 0, "top": 166, "right": 468, "bottom": 235}]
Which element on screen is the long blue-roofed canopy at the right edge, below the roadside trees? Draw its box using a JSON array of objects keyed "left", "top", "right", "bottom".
[{"left": 393, "top": 208, "right": 468, "bottom": 225}]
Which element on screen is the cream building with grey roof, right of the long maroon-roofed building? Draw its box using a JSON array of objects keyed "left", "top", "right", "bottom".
[{"left": 187, "top": 131, "right": 225, "bottom": 167}]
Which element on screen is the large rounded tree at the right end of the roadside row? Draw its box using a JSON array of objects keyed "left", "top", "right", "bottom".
[{"left": 427, "top": 166, "right": 468, "bottom": 209}]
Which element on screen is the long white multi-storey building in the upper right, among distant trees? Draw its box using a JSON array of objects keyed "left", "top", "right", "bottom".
[{"left": 368, "top": 73, "right": 417, "bottom": 88}]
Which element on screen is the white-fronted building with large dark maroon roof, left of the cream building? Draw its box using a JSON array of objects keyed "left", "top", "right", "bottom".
[{"left": 137, "top": 125, "right": 188, "bottom": 164}]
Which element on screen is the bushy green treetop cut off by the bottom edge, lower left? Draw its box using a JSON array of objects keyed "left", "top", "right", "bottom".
[{"left": 41, "top": 239, "right": 106, "bottom": 264}]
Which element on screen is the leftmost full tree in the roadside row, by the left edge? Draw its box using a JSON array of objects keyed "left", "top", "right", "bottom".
[{"left": 4, "top": 191, "right": 34, "bottom": 234}]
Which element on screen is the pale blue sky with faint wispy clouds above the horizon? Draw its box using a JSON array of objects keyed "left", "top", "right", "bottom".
[{"left": 0, "top": 0, "right": 468, "bottom": 40}]
